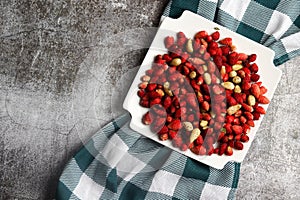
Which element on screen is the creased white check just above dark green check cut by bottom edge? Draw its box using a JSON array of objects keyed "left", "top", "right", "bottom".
[{"left": 116, "top": 153, "right": 146, "bottom": 181}]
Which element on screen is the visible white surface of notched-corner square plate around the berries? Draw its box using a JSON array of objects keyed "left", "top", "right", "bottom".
[{"left": 123, "top": 11, "right": 281, "bottom": 169}]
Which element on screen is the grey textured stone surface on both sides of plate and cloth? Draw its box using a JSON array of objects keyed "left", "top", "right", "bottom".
[{"left": 0, "top": 0, "right": 300, "bottom": 199}]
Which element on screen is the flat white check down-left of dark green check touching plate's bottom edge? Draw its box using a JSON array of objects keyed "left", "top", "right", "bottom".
[{"left": 149, "top": 170, "right": 180, "bottom": 196}]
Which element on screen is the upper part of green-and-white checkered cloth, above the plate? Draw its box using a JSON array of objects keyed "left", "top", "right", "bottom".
[{"left": 163, "top": 0, "right": 300, "bottom": 66}]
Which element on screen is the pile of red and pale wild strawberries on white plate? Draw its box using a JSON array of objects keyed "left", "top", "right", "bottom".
[{"left": 138, "top": 31, "right": 269, "bottom": 156}]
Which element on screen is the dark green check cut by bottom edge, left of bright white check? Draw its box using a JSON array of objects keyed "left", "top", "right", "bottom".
[{"left": 119, "top": 182, "right": 147, "bottom": 200}]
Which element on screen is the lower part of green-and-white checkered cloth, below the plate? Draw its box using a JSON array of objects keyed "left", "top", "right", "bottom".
[{"left": 56, "top": 114, "right": 240, "bottom": 200}]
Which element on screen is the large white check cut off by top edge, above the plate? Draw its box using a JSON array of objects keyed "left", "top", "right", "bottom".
[{"left": 220, "top": 0, "right": 251, "bottom": 21}]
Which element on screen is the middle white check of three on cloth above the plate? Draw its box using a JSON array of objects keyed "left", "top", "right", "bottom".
[{"left": 265, "top": 10, "right": 293, "bottom": 40}]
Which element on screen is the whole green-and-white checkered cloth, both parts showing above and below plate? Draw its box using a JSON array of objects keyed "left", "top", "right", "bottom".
[{"left": 56, "top": 0, "right": 300, "bottom": 200}]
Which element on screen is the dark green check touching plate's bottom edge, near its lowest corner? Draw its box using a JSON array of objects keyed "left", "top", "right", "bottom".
[{"left": 182, "top": 158, "right": 209, "bottom": 182}]
